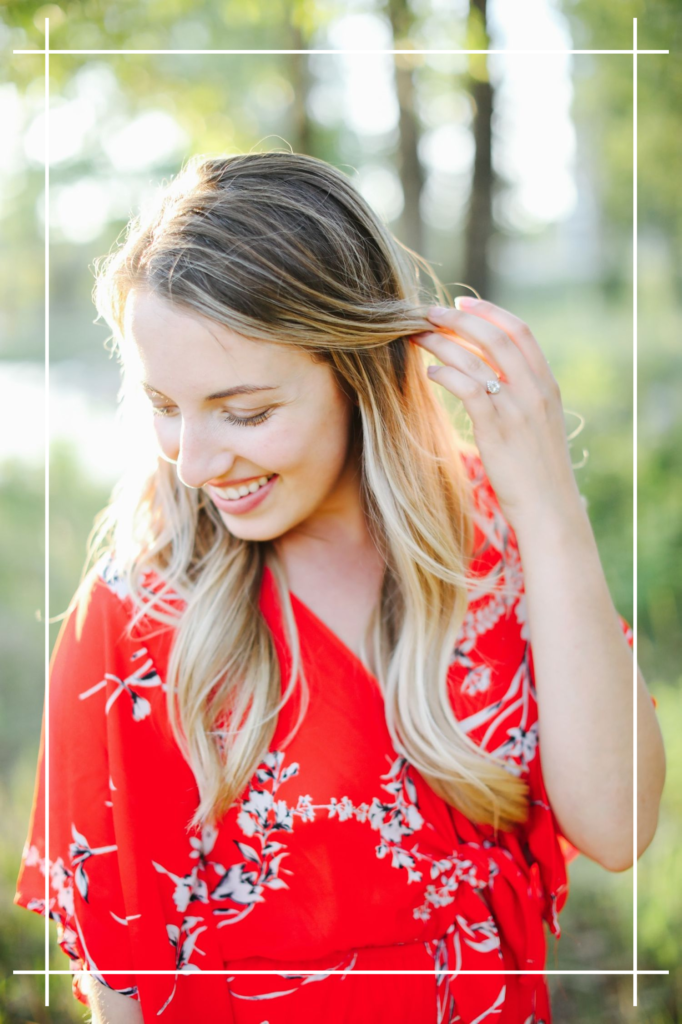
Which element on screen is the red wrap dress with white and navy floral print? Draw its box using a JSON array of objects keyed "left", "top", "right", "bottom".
[{"left": 14, "top": 456, "right": 632, "bottom": 1024}]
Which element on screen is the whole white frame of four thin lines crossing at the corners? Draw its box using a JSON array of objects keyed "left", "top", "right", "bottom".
[{"left": 12, "top": 17, "right": 670, "bottom": 1007}]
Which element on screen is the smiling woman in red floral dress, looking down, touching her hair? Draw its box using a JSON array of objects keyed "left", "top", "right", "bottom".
[{"left": 15, "top": 153, "right": 664, "bottom": 1024}]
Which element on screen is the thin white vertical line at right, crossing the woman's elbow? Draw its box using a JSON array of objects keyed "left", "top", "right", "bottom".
[{"left": 632, "top": 17, "right": 638, "bottom": 1007}]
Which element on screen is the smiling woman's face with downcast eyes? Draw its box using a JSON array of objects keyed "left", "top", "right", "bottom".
[{"left": 124, "top": 289, "right": 354, "bottom": 541}]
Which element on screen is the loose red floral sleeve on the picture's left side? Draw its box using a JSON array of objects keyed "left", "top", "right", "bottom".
[{"left": 14, "top": 568, "right": 138, "bottom": 1006}]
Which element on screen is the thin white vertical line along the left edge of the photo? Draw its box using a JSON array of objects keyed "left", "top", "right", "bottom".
[{"left": 44, "top": 17, "right": 50, "bottom": 1007}]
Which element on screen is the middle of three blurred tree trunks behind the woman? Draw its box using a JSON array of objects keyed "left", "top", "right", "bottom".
[{"left": 388, "top": 0, "right": 424, "bottom": 253}]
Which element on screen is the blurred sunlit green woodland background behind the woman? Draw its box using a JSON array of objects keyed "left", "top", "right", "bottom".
[{"left": 0, "top": 0, "right": 682, "bottom": 1024}]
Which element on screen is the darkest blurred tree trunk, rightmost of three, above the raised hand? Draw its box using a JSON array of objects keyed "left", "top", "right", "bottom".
[{"left": 464, "top": 0, "right": 494, "bottom": 298}]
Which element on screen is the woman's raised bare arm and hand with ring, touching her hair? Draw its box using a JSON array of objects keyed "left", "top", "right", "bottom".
[{"left": 413, "top": 296, "right": 666, "bottom": 871}]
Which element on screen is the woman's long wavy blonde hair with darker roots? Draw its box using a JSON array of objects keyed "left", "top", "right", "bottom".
[{"left": 72, "top": 152, "right": 527, "bottom": 828}]
